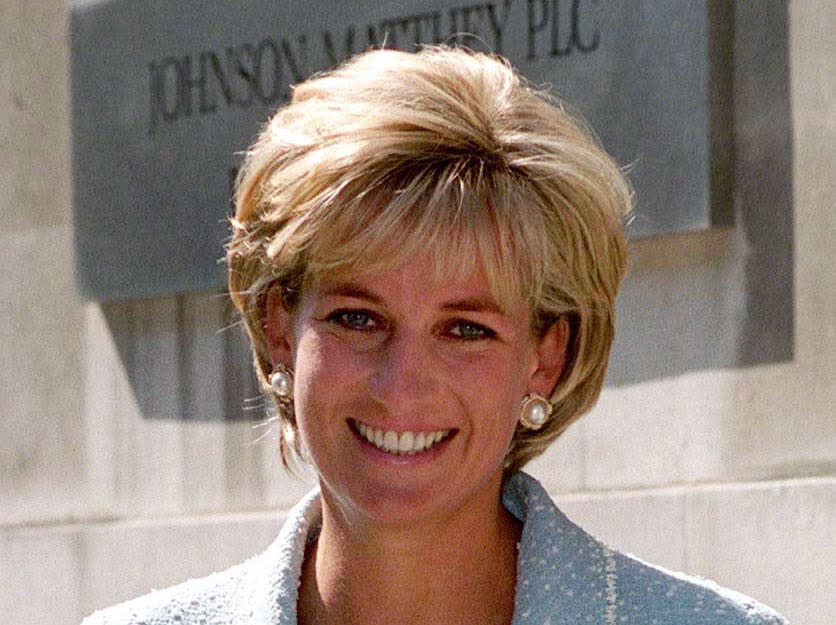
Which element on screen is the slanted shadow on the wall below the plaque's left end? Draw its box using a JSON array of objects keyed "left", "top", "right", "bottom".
[{"left": 102, "top": 293, "right": 266, "bottom": 421}]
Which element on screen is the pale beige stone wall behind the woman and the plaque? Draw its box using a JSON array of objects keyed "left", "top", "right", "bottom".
[{"left": 0, "top": 0, "right": 836, "bottom": 625}]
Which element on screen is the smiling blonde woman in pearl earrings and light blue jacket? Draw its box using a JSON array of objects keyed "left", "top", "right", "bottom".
[{"left": 83, "top": 47, "right": 783, "bottom": 625}]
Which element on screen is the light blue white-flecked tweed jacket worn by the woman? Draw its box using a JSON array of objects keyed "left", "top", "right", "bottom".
[{"left": 82, "top": 473, "right": 785, "bottom": 625}]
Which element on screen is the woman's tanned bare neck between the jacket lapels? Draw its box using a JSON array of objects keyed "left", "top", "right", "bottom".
[{"left": 299, "top": 476, "right": 521, "bottom": 625}]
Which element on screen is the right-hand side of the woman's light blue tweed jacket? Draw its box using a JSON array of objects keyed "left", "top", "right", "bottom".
[{"left": 503, "top": 473, "right": 786, "bottom": 625}]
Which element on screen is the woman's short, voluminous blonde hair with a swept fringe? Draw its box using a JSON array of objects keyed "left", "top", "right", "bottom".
[{"left": 227, "top": 46, "right": 631, "bottom": 470}]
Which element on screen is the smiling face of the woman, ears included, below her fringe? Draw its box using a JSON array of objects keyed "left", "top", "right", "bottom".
[{"left": 267, "top": 254, "right": 567, "bottom": 524}]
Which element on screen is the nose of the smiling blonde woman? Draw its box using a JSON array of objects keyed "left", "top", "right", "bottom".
[{"left": 369, "top": 331, "right": 439, "bottom": 416}]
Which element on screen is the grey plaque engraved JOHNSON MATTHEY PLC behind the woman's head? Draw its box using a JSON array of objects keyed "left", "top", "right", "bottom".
[{"left": 69, "top": 0, "right": 733, "bottom": 299}]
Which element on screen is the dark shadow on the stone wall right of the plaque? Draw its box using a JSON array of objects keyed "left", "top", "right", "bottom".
[{"left": 608, "top": 0, "right": 794, "bottom": 385}]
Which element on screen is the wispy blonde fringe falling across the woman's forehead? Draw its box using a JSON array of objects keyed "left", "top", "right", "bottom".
[{"left": 290, "top": 172, "right": 545, "bottom": 314}]
